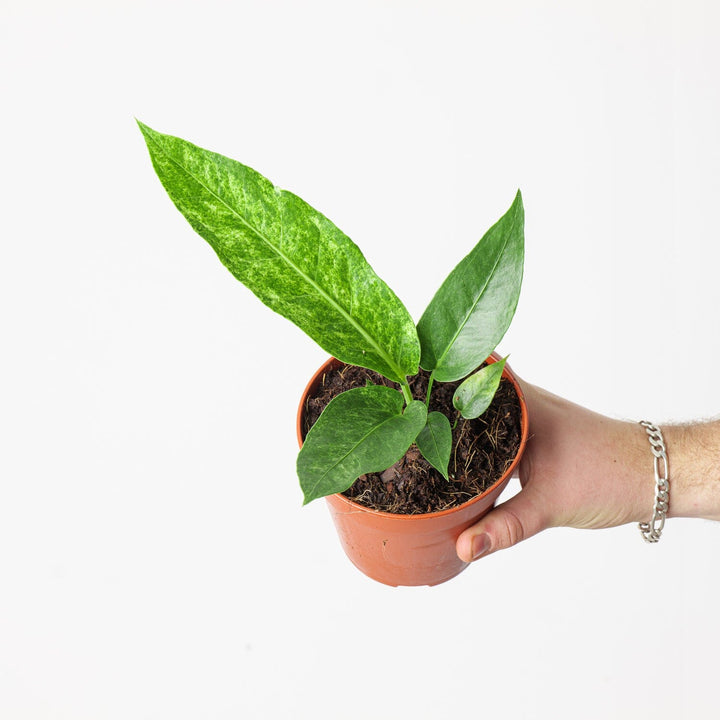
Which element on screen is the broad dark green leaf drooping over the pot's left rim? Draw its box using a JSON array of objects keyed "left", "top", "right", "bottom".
[{"left": 297, "top": 385, "right": 427, "bottom": 504}]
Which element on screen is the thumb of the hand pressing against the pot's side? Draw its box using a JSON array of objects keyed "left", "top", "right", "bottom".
[{"left": 455, "top": 487, "right": 549, "bottom": 562}]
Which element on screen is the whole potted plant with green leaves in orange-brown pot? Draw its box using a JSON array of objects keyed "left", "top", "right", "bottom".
[{"left": 138, "top": 122, "right": 528, "bottom": 585}]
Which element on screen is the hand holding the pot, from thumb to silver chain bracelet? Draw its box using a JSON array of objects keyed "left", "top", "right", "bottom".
[{"left": 456, "top": 380, "right": 654, "bottom": 562}]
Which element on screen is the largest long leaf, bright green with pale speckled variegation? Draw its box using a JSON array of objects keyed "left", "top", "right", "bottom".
[{"left": 138, "top": 123, "right": 420, "bottom": 382}]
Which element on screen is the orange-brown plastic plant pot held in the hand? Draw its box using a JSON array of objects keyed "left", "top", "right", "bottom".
[{"left": 297, "top": 355, "right": 528, "bottom": 586}]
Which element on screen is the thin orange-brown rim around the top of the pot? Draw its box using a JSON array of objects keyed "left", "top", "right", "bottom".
[{"left": 296, "top": 352, "right": 530, "bottom": 521}]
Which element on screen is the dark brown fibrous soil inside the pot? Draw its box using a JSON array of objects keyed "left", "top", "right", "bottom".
[{"left": 305, "top": 365, "right": 521, "bottom": 515}]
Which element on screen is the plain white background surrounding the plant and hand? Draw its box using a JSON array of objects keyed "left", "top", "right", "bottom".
[{"left": 0, "top": 0, "right": 720, "bottom": 720}]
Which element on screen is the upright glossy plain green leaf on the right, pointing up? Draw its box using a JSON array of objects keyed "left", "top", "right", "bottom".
[{"left": 418, "top": 190, "right": 524, "bottom": 382}]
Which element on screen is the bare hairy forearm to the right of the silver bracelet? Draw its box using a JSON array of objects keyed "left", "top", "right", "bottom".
[{"left": 661, "top": 420, "right": 720, "bottom": 520}]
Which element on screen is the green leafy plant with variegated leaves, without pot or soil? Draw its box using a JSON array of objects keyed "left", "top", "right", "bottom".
[{"left": 138, "top": 122, "right": 524, "bottom": 503}]
